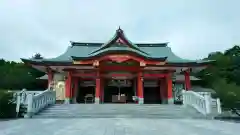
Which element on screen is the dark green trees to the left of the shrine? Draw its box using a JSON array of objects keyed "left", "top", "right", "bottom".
[{"left": 0, "top": 54, "right": 44, "bottom": 90}]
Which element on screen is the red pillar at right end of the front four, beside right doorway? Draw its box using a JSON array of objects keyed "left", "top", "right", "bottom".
[{"left": 166, "top": 73, "right": 173, "bottom": 103}]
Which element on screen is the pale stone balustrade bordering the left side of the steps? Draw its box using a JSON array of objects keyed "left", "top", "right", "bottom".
[{"left": 24, "top": 90, "right": 56, "bottom": 118}]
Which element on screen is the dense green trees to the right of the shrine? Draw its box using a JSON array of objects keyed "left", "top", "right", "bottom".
[{"left": 197, "top": 45, "right": 240, "bottom": 108}]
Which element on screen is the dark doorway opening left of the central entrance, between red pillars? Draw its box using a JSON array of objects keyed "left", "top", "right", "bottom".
[{"left": 76, "top": 86, "right": 95, "bottom": 103}]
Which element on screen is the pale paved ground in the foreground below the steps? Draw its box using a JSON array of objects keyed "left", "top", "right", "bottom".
[{"left": 0, "top": 118, "right": 240, "bottom": 135}]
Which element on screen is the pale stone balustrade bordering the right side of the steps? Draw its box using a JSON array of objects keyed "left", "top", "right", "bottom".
[{"left": 183, "top": 90, "right": 211, "bottom": 115}]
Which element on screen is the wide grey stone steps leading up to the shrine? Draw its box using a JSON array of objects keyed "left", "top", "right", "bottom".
[{"left": 33, "top": 104, "right": 206, "bottom": 119}]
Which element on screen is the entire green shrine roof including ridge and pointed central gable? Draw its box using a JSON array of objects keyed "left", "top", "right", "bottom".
[{"left": 22, "top": 28, "right": 210, "bottom": 64}]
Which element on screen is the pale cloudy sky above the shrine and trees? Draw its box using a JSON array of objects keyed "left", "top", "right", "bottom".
[{"left": 0, "top": 0, "right": 240, "bottom": 61}]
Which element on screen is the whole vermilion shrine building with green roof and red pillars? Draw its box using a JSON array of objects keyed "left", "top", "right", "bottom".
[{"left": 22, "top": 28, "right": 210, "bottom": 104}]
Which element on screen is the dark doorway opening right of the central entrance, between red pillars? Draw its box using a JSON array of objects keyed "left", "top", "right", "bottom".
[{"left": 144, "top": 86, "right": 161, "bottom": 104}]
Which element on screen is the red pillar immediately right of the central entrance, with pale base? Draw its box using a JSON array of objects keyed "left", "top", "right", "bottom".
[{"left": 137, "top": 72, "right": 144, "bottom": 104}]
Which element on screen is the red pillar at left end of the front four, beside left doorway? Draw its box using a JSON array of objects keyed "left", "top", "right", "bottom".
[{"left": 65, "top": 72, "right": 72, "bottom": 104}]
